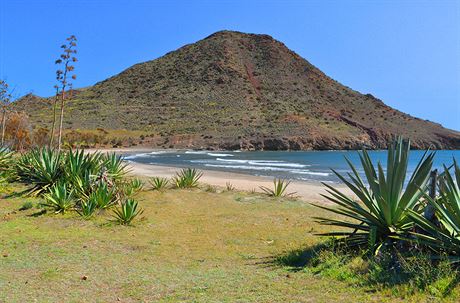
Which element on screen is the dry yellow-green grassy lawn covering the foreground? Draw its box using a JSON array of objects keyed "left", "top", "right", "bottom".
[{"left": 0, "top": 187, "right": 456, "bottom": 302}]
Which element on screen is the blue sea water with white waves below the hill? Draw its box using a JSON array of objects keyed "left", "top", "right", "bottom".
[{"left": 124, "top": 150, "right": 460, "bottom": 183}]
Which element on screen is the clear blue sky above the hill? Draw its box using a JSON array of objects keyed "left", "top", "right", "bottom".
[{"left": 0, "top": 0, "right": 460, "bottom": 130}]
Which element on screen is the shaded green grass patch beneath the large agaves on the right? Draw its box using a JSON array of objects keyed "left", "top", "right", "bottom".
[{"left": 258, "top": 241, "right": 460, "bottom": 298}]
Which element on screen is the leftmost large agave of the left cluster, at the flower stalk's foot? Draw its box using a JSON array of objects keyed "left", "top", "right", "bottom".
[{"left": 17, "top": 148, "right": 63, "bottom": 195}]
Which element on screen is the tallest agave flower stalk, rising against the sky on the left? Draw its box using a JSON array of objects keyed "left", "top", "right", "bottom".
[{"left": 55, "top": 35, "right": 77, "bottom": 150}]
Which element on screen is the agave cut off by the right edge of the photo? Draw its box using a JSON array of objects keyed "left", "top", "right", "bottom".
[{"left": 409, "top": 159, "right": 460, "bottom": 262}]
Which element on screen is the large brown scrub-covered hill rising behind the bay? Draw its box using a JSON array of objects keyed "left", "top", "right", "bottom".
[{"left": 15, "top": 31, "right": 460, "bottom": 150}]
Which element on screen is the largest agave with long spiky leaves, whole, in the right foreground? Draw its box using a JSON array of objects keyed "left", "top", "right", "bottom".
[{"left": 316, "top": 138, "right": 434, "bottom": 253}]
